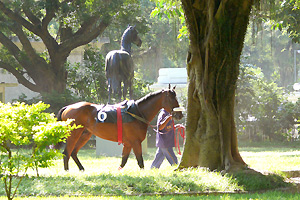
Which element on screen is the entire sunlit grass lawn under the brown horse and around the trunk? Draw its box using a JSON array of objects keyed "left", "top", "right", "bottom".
[{"left": 0, "top": 141, "right": 300, "bottom": 200}]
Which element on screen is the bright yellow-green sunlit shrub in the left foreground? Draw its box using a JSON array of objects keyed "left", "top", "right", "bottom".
[{"left": 0, "top": 102, "right": 77, "bottom": 199}]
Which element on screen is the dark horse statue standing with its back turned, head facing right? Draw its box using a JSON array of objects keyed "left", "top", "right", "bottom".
[{"left": 105, "top": 26, "right": 142, "bottom": 103}]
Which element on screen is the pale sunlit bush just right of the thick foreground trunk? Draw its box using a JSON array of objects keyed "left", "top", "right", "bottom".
[{"left": 235, "top": 66, "right": 299, "bottom": 140}]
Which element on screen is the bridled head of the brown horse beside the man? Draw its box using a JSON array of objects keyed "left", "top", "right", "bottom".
[{"left": 162, "top": 87, "right": 183, "bottom": 120}]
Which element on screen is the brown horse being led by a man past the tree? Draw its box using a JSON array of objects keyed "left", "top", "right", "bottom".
[{"left": 58, "top": 87, "right": 183, "bottom": 170}]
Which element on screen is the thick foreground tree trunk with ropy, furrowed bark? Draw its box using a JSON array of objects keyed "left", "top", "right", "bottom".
[{"left": 179, "top": 0, "right": 252, "bottom": 170}]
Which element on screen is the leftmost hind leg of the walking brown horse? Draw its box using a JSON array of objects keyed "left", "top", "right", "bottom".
[{"left": 63, "top": 128, "right": 84, "bottom": 171}]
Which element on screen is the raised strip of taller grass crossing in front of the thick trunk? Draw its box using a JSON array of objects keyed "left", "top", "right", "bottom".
[{"left": 0, "top": 169, "right": 291, "bottom": 196}]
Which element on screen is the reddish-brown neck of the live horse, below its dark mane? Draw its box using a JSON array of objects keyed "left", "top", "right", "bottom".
[{"left": 139, "top": 94, "right": 163, "bottom": 122}]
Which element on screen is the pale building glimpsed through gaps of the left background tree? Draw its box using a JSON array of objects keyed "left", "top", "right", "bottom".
[{"left": 0, "top": 37, "right": 110, "bottom": 103}]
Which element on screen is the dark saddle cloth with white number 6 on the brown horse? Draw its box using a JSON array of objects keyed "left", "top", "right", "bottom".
[{"left": 96, "top": 100, "right": 139, "bottom": 123}]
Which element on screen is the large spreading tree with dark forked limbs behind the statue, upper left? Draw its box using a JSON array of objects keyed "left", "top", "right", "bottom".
[{"left": 0, "top": 0, "right": 138, "bottom": 93}]
